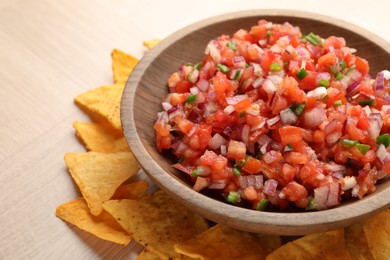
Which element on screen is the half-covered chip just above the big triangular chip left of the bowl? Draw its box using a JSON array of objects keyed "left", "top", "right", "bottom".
[{"left": 73, "top": 122, "right": 130, "bottom": 153}]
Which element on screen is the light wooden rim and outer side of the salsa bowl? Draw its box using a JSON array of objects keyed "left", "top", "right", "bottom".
[{"left": 121, "top": 9, "right": 390, "bottom": 235}]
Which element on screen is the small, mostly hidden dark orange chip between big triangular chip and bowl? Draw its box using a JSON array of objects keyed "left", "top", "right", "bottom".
[{"left": 111, "top": 180, "right": 149, "bottom": 200}]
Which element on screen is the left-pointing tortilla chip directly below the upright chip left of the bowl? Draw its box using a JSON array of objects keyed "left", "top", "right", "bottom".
[{"left": 74, "top": 84, "right": 124, "bottom": 131}]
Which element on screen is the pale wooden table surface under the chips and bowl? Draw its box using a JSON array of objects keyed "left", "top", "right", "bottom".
[{"left": 0, "top": 0, "right": 390, "bottom": 259}]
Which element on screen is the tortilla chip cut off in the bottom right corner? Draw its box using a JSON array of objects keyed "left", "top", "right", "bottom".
[{"left": 363, "top": 210, "right": 390, "bottom": 259}]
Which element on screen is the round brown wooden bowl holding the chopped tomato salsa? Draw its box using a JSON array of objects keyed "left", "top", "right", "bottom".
[{"left": 121, "top": 10, "right": 390, "bottom": 235}]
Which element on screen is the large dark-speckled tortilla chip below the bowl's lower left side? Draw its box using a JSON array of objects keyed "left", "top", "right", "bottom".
[{"left": 103, "top": 191, "right": 208, "bottom": 259}]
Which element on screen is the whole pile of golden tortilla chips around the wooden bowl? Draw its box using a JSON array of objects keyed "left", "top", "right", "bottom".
[{"left": 56, "top": 40, "right": 390, "bottom": 260}]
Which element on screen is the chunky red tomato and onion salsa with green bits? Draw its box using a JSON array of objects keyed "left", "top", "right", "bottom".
[{"left": 154, "top": 20, "right": 390, "bottom": 211}]
